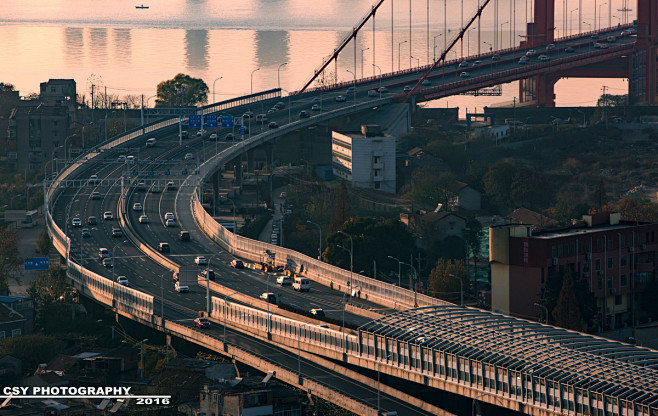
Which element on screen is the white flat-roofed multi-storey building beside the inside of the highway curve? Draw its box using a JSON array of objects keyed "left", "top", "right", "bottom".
[{"left": 331, "top": 125, "right": 396, "bottom": 193}]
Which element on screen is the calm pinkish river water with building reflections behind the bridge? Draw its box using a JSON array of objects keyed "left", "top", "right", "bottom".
[{"left": 0, "top": 0, "right": 632, "bottom": 114}]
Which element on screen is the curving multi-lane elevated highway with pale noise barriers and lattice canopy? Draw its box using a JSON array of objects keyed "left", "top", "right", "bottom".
[{"left": 46, "top": 23, "right": 658, "bottom": 415}]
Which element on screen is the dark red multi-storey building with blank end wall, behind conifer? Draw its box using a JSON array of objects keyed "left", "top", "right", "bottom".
[{"left": 489, "top": 213, "right": 658, "bottom": 330}]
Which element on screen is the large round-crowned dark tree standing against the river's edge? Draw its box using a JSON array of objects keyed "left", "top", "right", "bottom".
[{"left": 155, "top": 74, "right": 208, "bottom": 107}]
